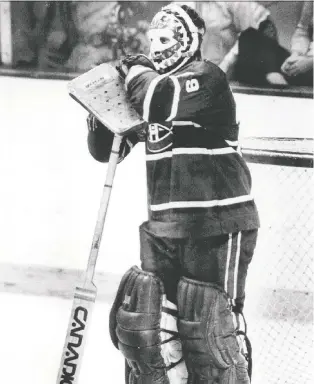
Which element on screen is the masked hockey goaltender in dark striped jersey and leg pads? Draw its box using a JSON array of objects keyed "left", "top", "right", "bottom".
[{"left": 88, "top": 4, "right": 259, "bottom": 384}]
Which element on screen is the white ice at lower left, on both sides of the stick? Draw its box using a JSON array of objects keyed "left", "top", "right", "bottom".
[{"left": 0, "top": 293, "right": 124, "bottom": 384}]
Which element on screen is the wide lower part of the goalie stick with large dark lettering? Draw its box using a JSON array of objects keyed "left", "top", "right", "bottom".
[{"left": 57, "top": 283, "right": 97, "bottom": 384}]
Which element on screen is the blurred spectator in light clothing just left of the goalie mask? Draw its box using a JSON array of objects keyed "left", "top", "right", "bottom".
[{"left": 66, "top": 1, "right": 148, "bottom": 72}]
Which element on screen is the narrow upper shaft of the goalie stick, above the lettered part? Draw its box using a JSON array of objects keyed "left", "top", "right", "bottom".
[{"left": 85, "top": 135, "right": 122, "bottom": 282}]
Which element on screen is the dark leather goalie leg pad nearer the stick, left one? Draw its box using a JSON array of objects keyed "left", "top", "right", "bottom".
[{"left": 110, "top": 266, "right": 187, "bottom": 384}]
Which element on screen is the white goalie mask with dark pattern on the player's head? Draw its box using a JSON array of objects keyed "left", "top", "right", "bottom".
[{"left": 148, "top": 4, "right": 205, "bottom": 73}]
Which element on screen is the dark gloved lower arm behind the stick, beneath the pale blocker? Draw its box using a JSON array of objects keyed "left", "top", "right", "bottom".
[{"left": 87, "top": 114, "right": 144, "bottom": 163}]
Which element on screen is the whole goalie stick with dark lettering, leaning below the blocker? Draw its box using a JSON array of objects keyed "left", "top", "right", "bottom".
[{"left": 57, "top": 135, "right": 122, "bottom": 384}]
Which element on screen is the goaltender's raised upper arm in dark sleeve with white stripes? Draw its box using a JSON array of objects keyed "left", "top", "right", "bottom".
[{"left": 125, "top": 61, "right": 232, "bottom": 124}]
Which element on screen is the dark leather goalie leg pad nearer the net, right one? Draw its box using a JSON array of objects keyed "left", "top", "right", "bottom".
[{"left": 178, "top": 277, "right": 250, "bottom": 384}]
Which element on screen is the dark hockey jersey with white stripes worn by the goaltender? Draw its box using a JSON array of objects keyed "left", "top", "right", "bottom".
[{"left": 88, "top": 61, "right": 259, "bottom": 237}]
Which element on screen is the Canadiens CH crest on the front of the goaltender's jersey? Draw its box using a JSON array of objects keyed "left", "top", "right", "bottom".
[{"left": 147, "top": 123, "right": 173, "bottom": 153}]
